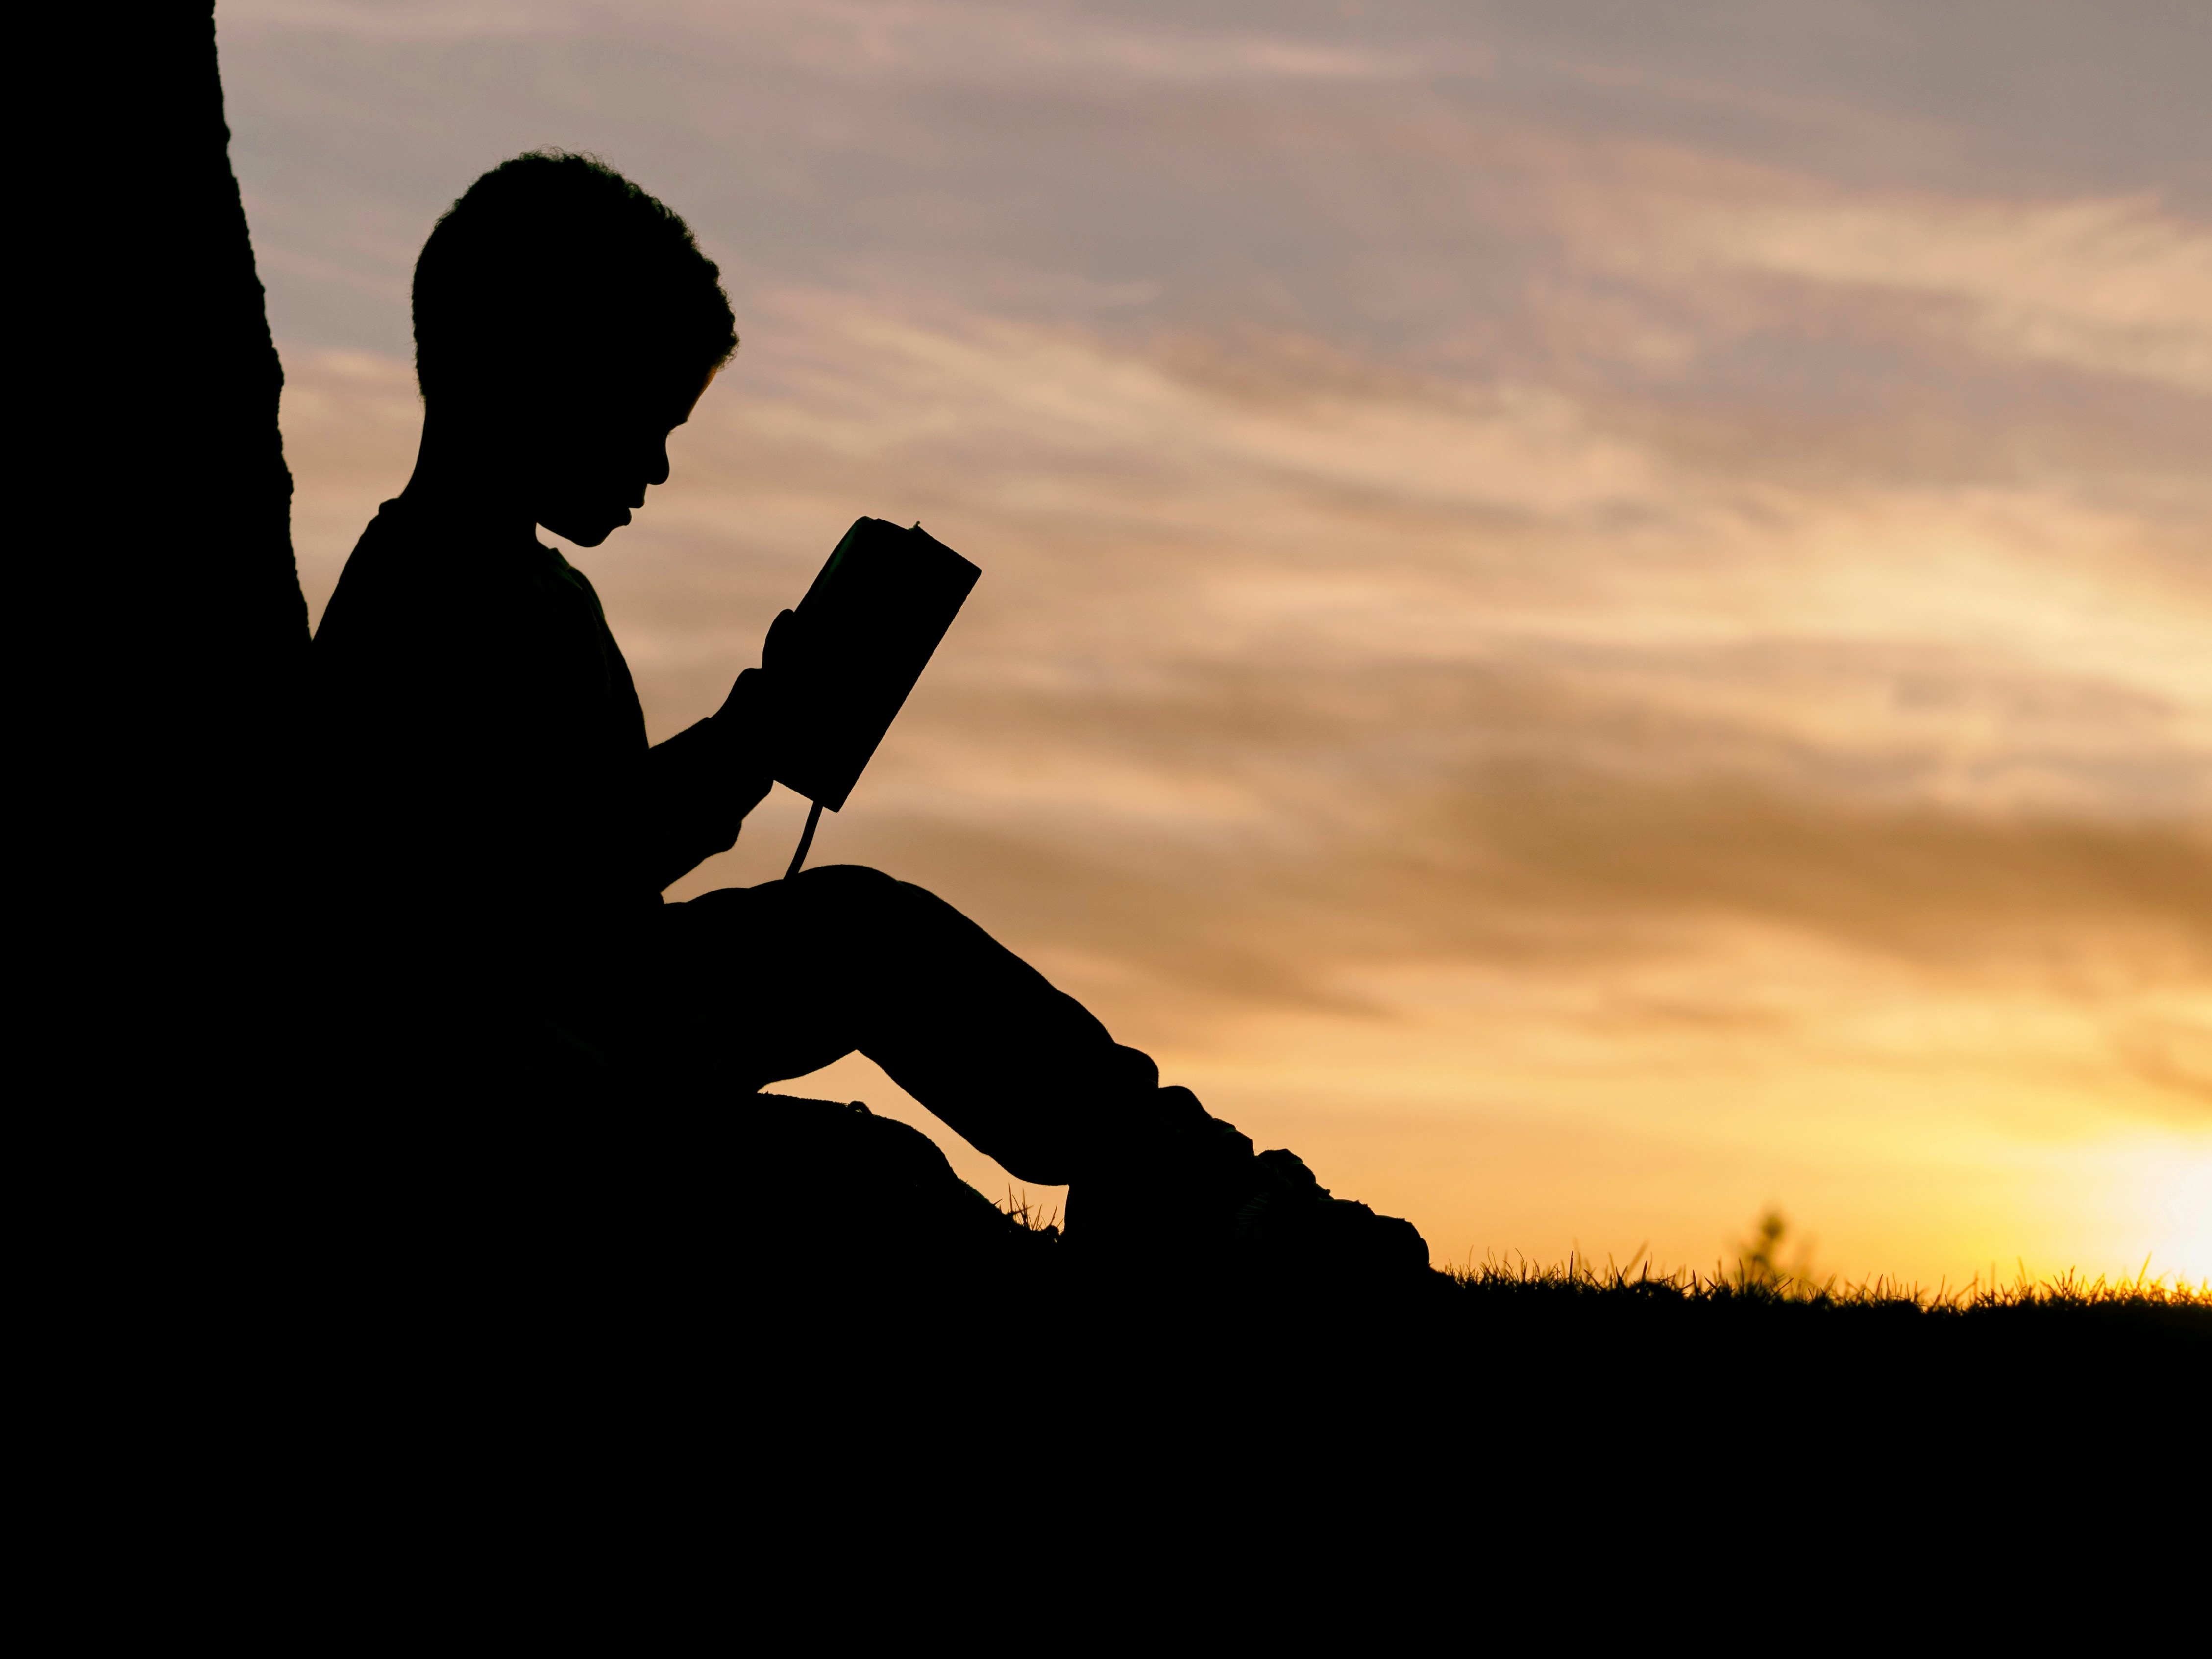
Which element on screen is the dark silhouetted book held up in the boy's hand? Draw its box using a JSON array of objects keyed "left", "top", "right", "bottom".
[{"left": 776, "top": 518, "right": 982, "bottom": 814}]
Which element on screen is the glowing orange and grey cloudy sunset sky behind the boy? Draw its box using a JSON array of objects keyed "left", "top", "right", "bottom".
[{"left": 217, "top": 0, "right": 2212, "bottom": 1285}]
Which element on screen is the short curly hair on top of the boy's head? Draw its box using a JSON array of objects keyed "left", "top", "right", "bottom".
[{"left": 414, "top": 150, "right": 737, "bottom": 398}]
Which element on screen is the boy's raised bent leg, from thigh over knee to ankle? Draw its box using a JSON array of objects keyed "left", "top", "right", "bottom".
[{"left": 648, "top": 865, "right": 1205, "bottom": 1184}]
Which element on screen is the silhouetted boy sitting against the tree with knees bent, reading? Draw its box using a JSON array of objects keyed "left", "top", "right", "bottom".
[{"left": 314, "top": 152, "right": 1427, "bottom": 1267}]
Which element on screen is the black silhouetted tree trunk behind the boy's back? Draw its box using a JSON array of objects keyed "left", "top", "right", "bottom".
[{"left": 16, "top": 4, "right": 307, "bottom": 1097}]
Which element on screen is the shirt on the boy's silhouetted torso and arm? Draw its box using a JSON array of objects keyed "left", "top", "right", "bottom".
[{"left": 312, "top": 502, "right": 759, "bottom": 1013}]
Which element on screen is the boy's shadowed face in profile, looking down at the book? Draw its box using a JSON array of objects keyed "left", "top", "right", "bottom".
[{"left": 526, "top": 370, "right": 719, "bottom": 546}]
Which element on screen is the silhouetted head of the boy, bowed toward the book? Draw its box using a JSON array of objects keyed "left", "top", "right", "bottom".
[{"left": 414, "top": 150, "right": 737, "bottom": 546}]
